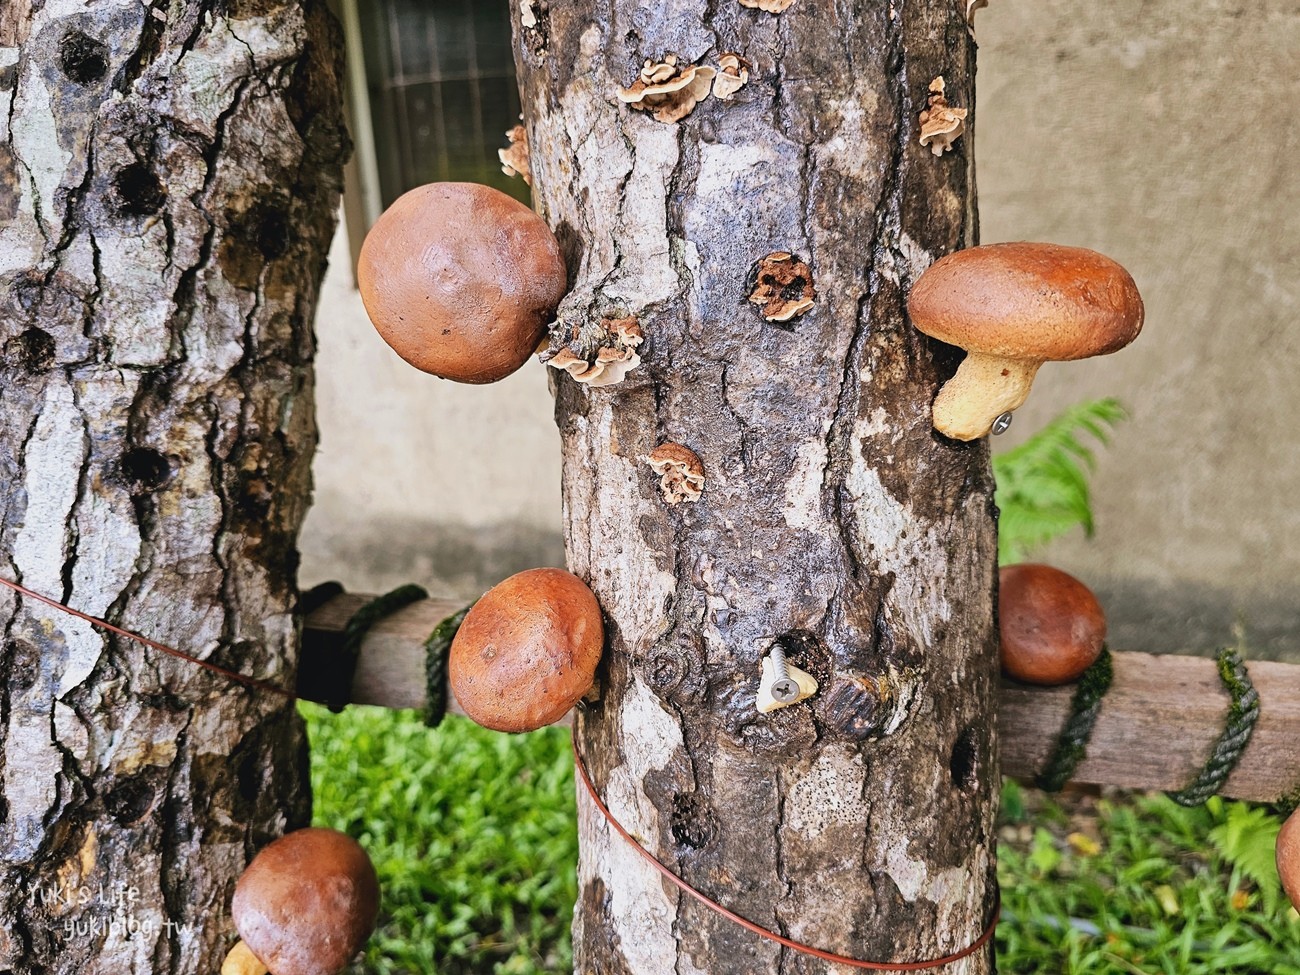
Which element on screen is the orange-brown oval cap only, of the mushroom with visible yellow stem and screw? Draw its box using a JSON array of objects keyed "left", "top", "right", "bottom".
[{"left": 907, "top": 241, "right": 1143, "bottom": 361}]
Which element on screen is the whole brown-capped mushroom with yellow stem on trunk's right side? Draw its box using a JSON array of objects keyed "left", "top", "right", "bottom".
[{"left": 907, "top": 242, "right": 1143, "bottom": 441}]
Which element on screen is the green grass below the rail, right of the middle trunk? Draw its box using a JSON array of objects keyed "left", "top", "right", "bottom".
[{"left": 997, "top": 783, "right": 1300, "bottom": 975}]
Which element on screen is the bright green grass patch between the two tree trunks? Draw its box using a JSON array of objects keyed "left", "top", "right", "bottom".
[{"left": 302, "top": 705, "right": 577, "bottom": 975}]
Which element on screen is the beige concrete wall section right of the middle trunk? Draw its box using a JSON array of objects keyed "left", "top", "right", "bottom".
[{"left": 976, "top": 0, "right": 1300, "bottom": 653}]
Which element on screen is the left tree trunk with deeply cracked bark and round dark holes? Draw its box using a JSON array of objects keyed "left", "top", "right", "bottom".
[{"left": 0, "top": 0, "right": 346, "bottom": 975}]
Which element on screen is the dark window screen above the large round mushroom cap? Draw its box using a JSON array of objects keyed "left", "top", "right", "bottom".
[{"left": 359, "top": 0, "right": 528, "bottom": 207}]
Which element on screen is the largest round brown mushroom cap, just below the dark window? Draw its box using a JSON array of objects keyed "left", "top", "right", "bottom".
[{"left": 356, "top": 183, "right": 566, "bottom": 382}]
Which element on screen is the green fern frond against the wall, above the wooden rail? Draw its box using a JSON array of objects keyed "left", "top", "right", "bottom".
[{"left": 993, "top": 397, "right": 1128, "bottom": 564}]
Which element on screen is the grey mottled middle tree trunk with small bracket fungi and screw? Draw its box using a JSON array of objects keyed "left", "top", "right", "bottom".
[{"left": 516, "top": 0, "right": 997, "bottom": 975}]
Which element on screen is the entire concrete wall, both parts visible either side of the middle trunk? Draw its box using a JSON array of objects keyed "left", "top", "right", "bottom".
[{"left": 303, "top": 0, "right": 1300, "bottom": 659}]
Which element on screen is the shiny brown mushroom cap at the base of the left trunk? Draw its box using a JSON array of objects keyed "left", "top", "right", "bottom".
[{"left": 231, "top": 827, "right": 380, "bottom": 975}]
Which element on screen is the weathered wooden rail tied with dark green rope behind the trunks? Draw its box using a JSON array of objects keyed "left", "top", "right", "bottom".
[{"left": 299, "top": 593, "right": 1300, "bottom": 802}]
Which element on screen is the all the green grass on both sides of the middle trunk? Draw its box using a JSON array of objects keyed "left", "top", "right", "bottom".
[{"left": 312, "top": 705, "right": 1300, "bottom": 975}]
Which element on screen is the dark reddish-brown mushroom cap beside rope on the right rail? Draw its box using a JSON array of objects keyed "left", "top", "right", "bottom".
[{"left": 997, "top": 563, "right": 1106, "bottom": 684}]
